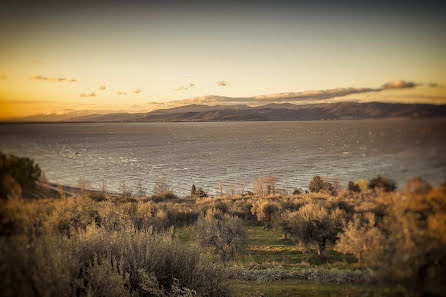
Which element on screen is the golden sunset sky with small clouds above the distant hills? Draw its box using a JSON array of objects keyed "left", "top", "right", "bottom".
[{"left": 0, "top": 0, "right": 446, "bottom": 120}]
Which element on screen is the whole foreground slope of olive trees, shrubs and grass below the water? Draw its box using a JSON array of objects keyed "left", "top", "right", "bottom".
[{"left": 0, "top": 155, "right": 446, "bottom": 296}]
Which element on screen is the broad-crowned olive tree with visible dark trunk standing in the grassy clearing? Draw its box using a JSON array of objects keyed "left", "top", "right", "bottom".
[{"left": 283, "top": 202, "right": 346, "bottom": 257}]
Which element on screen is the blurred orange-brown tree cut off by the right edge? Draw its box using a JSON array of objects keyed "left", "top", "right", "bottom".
[{"left": 383, "top": 186, "right": 446, "bottom": 290}]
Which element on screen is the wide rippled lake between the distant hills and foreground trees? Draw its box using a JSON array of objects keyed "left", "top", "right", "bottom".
[{"left": 0, "top": 119, "right": 446, "bottom": 195}]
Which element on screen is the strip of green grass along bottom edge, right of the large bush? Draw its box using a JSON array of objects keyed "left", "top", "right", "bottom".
[{"left": 229, "top": 279, "right": 412, "bottom": 297}]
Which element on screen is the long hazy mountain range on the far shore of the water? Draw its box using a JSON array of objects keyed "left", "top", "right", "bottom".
[{"left": 8, "top": 102, "right": 446, "bottom": 122}]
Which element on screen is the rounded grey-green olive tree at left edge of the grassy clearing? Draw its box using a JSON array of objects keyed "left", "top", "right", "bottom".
[{"left": 196, "top": 208, "right": 246, "bottom": 263}]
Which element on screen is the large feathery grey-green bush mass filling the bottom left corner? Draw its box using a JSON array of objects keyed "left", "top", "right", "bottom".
[{"left": 0, "top": 225, "right": 228, "bottom": 296}]
